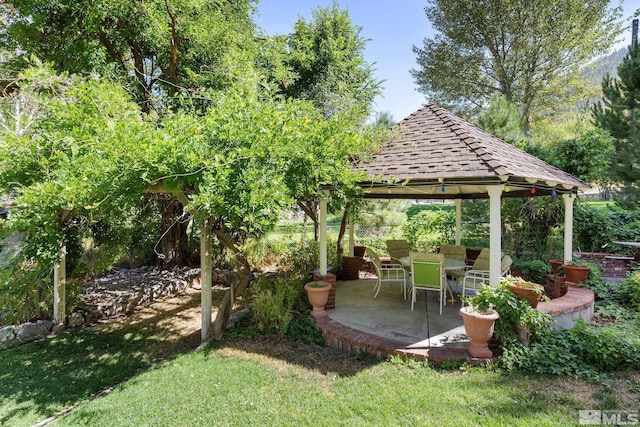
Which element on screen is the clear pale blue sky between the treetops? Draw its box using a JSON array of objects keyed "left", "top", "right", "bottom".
[{"left": 255, "top": 0, "right": 639, "bottom": 121}]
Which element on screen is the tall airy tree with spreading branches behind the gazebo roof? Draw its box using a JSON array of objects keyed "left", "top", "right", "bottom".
[{"left": 412, "top": 0, "right": 620, "bottom": 131}]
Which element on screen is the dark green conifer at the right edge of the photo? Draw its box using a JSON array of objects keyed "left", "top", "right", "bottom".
[{"left": 593, "top": 44, "right": 640, "bottom": 208}]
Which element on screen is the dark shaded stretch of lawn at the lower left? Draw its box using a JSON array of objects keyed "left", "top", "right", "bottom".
[{"left": 0, "top": 312, "right": 199, "bottom": 425}]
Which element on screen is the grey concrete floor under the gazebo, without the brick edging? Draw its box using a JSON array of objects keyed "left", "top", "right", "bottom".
[{"left": 327, "top": 274, "right": 469, "bottom": 348}]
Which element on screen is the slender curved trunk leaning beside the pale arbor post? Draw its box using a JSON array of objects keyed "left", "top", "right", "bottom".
[{"left": 211, "top": 228, "right": 251, "bottom": 340}]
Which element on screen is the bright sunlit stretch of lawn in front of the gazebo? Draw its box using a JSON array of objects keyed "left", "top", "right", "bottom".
[{"left": 52, "top": 347, "right": 584, "bottom": 426}]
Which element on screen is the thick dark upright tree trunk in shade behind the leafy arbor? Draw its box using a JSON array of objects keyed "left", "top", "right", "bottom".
[{"left": 158, "top": 199, "right": 190, "bottom": 268}]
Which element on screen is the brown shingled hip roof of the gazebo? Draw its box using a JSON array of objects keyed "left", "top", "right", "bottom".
[{"left": 357, "top": 103, "right": 589, "bottom": 199}]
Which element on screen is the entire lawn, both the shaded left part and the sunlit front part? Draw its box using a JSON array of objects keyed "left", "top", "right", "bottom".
[{"left": 0, "top": 325, "right": 636, "bottom": 426}]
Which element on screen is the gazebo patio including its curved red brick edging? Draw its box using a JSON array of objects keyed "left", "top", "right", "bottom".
[{"left": 318, "top": 273, "right": 596, "bottom": 364}]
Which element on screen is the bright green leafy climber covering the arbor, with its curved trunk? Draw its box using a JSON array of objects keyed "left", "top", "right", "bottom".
[{"left": 0, "top": 68, "right": 372, "bottom": 336}]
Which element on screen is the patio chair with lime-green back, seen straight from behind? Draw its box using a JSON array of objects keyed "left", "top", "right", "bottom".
[{"left": 411, "top": 253, "right": 447, "bottom": 314}]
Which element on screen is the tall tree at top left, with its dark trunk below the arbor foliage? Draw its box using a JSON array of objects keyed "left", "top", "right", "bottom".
[{"left": 1, "top": 0, "right": 255, "bottom": 267}]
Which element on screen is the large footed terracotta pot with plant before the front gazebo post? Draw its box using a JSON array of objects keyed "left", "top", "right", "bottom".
[{"left": 460, "top": 286, "right": 500, "bottom": 357}]
